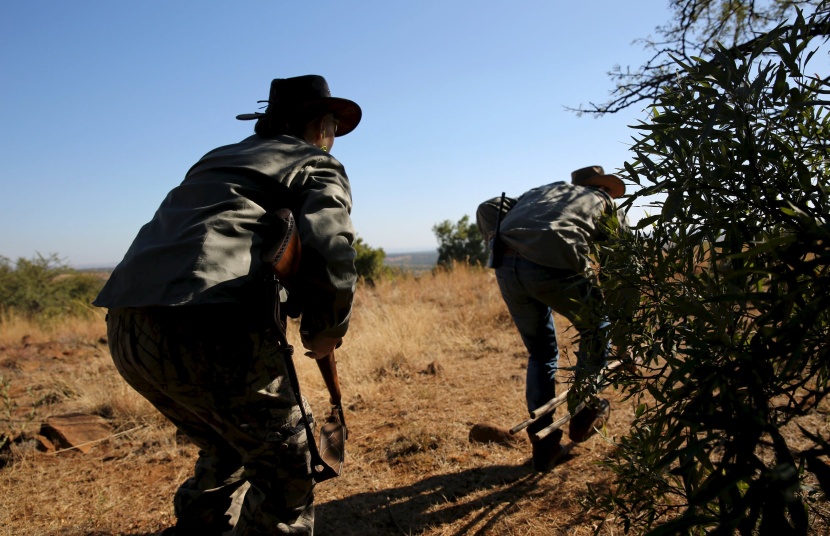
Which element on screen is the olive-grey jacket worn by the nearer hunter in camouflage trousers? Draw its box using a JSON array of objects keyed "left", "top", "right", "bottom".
[{"left": 93, "top": 135, "right": 356, "bottom": 337}]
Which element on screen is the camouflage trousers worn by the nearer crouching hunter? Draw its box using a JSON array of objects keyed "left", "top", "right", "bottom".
[{"left": 107, "top": 306, "right": 314, "bottom": 536}]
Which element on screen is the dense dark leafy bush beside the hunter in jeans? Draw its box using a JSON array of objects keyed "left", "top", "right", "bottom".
[{"left": 592, "top": 7, "right": 830, "bottom": 535}]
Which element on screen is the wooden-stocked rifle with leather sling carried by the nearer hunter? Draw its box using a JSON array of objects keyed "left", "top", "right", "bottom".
[{"left": 261, "top": 208, "right": 348, "bottom": 482}]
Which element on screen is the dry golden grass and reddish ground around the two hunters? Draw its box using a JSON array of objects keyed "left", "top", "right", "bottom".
[{"left": 0, "top": 268, "right": 680, "bottom": 536}]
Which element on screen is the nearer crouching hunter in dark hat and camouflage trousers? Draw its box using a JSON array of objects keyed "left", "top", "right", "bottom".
[{"left": 94, "top": 75, "right": 361, "bottom": 535}]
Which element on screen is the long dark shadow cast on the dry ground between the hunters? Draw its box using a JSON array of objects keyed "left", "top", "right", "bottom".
[{"left": 314, "top": 465, "right": 542, "bottom": 536}]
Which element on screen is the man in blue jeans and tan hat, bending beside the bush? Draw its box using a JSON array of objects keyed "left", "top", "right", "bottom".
[{"left": 476, "top": 166, "right": 625, "bottom": 471}]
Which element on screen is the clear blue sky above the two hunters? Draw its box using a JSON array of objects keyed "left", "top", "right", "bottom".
[{"left": 0, "top": 0, "right": 669, "bottom": 267}]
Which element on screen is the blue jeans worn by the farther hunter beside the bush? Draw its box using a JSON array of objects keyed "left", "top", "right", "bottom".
[{"left": 496, "top": 255, "right": 610, "bottom": 432}]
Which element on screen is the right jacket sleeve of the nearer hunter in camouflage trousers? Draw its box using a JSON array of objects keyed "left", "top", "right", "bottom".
[{"left": 294, "top": 157, "right": 357, "bottom": 337}]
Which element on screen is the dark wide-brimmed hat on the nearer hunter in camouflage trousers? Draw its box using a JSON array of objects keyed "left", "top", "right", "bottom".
[{"left": 236, "top": 74, "right": 363, "bottom": 136}]
